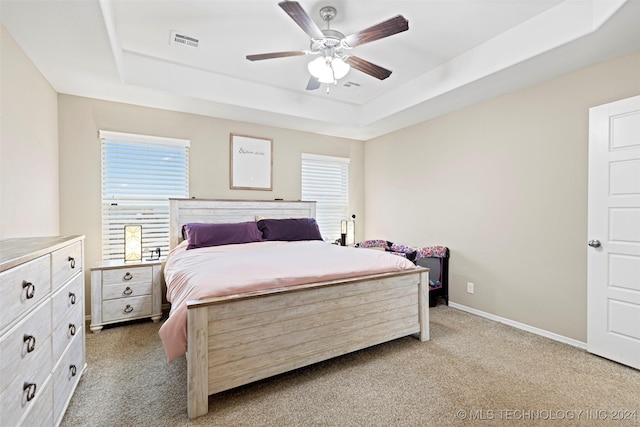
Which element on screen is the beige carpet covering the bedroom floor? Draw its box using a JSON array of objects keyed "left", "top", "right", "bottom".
[{"left": 62, "top": 305, "right": 640, "bottom": 426}]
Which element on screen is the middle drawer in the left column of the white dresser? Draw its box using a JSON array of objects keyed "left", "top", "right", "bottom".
[{"left": 0, "top": 300, "right": 52, "bottom": 390}]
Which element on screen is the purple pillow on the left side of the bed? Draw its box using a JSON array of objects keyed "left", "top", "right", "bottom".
[{"left": 183, "top": 221, "right": 262, "bottom": 250}]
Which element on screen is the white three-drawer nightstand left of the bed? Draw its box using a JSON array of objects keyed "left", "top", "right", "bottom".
[{"left": 90, "top": 260, "right": 163, "bottom": 333}]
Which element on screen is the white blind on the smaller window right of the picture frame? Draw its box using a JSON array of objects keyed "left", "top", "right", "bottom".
[{"left": 302, "top": 153, "right": 349, "bottom": 242}]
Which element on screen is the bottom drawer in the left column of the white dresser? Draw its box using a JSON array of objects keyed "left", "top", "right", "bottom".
[{"left": 0, "top": 336, "right": 52, "bottom": 426}]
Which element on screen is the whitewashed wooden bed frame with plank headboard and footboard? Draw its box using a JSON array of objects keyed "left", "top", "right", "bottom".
[{"left": 161, "top": 199, "right": 429, "bottom": 418}]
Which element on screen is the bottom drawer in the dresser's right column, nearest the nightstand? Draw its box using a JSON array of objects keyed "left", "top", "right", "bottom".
[{"left": 53, "top": 336, "right": 85, "bottom": 421}]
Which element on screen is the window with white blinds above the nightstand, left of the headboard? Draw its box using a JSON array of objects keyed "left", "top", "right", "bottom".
[{"left": 100, "top": 131, "right": 189, "bottom": 260}]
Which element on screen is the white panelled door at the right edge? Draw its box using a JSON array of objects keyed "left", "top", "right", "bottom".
[{"left": 585, "top": 96, "right": 640, "bottom": 369}]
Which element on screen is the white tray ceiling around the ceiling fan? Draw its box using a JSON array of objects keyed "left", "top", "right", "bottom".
[{"left": 0, "top": 0, "right": 640, "bottom": 140}]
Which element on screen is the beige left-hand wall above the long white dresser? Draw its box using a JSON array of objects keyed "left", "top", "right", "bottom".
[{"left": 0, "top": 26, "right": 59, "bottom": 239}]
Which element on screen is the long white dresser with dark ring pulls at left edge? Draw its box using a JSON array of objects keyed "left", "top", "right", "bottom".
[{"left": 0, "top": 236, "right": 86, "bottom": 426}]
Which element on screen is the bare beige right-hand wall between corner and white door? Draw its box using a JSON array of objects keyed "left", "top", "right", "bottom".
[{"left": 365, "top": 52, "right": 640, "bottom": 342}]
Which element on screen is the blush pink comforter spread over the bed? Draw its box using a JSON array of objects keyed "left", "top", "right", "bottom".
[{"left": 159, "top": 240, "right": 416, "bottom": 362}]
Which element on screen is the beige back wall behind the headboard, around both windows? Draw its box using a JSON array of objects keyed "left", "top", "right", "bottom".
[{"left": 58, "top": 94, "right": 364, "bottom": 313}]
